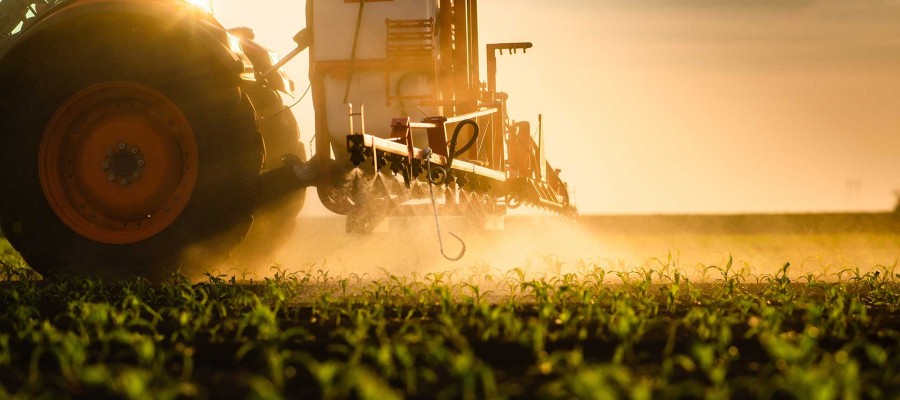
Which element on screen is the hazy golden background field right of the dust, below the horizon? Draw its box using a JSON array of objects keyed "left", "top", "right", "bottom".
[{"left": 579, "top": 213, "right": 900, "bottom": 276}]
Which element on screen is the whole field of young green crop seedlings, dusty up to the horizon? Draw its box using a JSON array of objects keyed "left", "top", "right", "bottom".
[{"left": 0, "top": 214, "right": 900, "bottom": 399}]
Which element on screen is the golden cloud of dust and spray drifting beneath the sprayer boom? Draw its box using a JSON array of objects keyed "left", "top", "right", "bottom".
[{"left": 214, "top": 215, "right": 602, "bottom": 279}]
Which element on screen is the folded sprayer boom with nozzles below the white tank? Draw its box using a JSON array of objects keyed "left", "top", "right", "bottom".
[{"left": 347, "top": 109, "right": 575, "bottom": 219}]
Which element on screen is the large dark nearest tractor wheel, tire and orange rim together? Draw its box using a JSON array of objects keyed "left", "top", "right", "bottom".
[{"left": 0, "top": 12, "right": 263, "bottom": 280}]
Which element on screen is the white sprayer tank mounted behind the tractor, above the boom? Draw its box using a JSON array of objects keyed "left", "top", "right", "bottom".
[{"left": 311, "top": 0, "right": 441, "bottom": 152}]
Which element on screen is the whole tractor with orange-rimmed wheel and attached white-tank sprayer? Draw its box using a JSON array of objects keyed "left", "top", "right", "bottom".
[{"left": 0, "top": 0, "right": 576, "bottom": 280}]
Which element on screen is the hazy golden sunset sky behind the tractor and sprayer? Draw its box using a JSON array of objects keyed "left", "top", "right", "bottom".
[{"left": 213, "top": 0, "right": 900, "bottom": 214}]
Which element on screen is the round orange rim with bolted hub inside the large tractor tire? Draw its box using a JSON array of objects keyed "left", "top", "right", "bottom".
[{"left": 38, "top": 82, "right": 198, "bottom": 244}]
